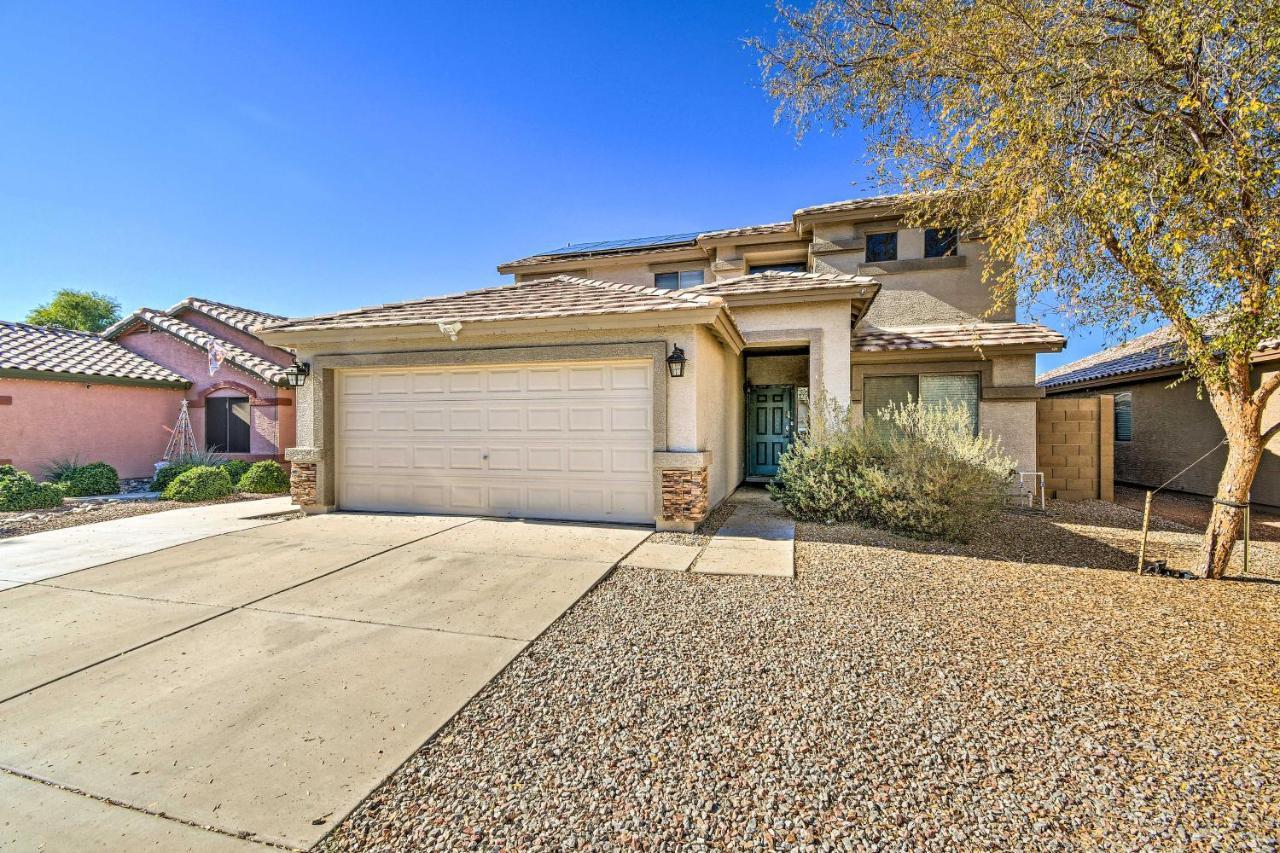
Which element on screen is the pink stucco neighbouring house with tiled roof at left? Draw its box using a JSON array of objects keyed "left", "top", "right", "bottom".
[{"left": 0, "top": 297, "right": 293, "bottom": 479}]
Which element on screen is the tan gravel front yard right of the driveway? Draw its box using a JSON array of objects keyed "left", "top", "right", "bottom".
[{"left": 321, "top": 503, "right": 1280, "bottom": 850}]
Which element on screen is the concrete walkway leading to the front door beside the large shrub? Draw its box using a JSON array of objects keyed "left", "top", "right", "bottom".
[{"left": 694, "top": 487, "right": 796, "bottom": 578}]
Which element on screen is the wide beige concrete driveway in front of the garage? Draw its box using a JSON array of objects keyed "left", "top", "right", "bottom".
[{"left": 0, "top": 514, "right": 648, "bottom": 850}]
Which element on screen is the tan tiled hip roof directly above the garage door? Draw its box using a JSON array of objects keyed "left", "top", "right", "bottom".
[{"left": 264, "top": 275, "right": 722, "bottom": 332}]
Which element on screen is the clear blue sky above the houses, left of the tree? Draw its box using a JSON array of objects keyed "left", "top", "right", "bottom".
[{"left": 0, "top": 0, "right": 1098, "bottom": 369}]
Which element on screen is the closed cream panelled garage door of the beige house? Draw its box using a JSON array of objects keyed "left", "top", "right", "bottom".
[{"left": 335, "top": 361, "right": 654, "bottom": 523}]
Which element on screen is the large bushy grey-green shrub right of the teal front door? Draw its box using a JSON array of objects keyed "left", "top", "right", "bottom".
[{"left": 769, "top": 394, "right": 1015, "bottom": 542}]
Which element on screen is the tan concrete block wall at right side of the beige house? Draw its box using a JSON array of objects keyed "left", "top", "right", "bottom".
[{"left": 1036, "top": 396, "right": 1115, "bottom": 501}]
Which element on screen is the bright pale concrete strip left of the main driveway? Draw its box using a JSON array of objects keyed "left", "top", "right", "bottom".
[{"left": 0, "top": 497, "right": 294, "bottom": 589}]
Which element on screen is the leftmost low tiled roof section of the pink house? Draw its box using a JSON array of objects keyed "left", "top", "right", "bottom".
[{"left": 0, "top": 320, "right": 191, "bottom": 386}]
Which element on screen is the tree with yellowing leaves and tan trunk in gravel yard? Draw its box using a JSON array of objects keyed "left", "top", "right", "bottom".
[{"left": 755, "top": 0, "right": 1280, "bottom": 578}]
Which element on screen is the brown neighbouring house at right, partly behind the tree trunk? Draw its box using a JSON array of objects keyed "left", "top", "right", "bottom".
[{"left": 1037, "top": 318, "right": 1280, "bottom": 506}]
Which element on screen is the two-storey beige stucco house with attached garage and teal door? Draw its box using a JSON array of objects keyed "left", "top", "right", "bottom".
[{"left": 259, "top": 196, "right": 1065, "bottom": 530}]
